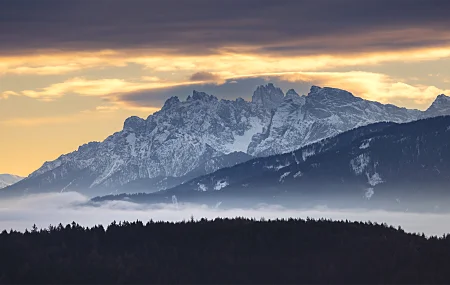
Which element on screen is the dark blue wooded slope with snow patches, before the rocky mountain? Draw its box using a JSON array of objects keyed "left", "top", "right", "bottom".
[{"left": 95, "top": 116, "right": 450, "bottom": 210}]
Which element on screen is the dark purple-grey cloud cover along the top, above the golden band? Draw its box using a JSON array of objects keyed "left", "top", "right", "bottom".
[{"left": 0, "top": 0, "right": 450, "bottom": 54}]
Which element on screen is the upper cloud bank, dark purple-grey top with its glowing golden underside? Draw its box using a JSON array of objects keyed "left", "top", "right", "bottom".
[{"left": 0, "top": 0, "right": 450, "bottom": 79}]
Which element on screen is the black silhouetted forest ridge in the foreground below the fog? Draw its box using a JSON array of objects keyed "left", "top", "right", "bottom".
[{"left": 0, "top": 219, "right": 450, "bottom": 285}]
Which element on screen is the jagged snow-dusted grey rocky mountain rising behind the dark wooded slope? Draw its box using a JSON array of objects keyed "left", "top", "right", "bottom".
[{"left": 4, "top": 84, "right": 450, "bottom": 195}]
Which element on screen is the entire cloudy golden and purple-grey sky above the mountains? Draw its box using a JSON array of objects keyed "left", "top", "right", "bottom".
[{"left": 0, "top": 0, "right": 450, "bottom": 176}]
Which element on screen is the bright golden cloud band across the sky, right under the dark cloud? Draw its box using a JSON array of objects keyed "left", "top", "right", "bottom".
[{"left": 0, "top": 44, "right": 450, "bottom": 76}]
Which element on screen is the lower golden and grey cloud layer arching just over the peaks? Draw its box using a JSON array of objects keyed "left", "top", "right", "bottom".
[{"left": 2, "top": 67, "right": 450, "bottom": 108}]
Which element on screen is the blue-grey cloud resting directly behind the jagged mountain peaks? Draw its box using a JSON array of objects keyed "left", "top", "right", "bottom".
[{"left": 118, "top": 77, "right": 311, "bottom": 107}]
